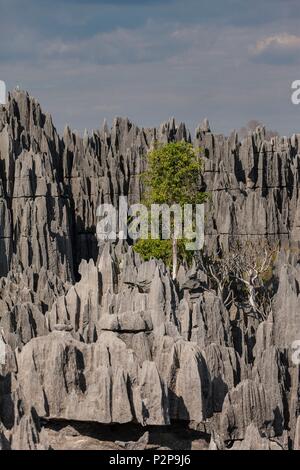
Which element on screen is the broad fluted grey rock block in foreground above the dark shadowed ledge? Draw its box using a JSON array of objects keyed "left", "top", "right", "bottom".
[{"left": 17, "top": 331, "right": 210, "bottom": 426}]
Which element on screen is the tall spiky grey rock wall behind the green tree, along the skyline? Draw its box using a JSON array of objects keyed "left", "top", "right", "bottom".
[{"left": 0, "top": 91, "right": 300, "bottom": 279}]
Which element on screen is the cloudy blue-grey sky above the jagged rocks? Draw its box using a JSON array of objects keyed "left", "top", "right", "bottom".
[{"left": 0, "top": 0, "right": 300, "bottom": 134}]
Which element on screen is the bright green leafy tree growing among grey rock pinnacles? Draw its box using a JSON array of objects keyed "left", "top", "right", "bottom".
[{"left": 135, "top": 141, "right": 207, "bottom": 279}]
